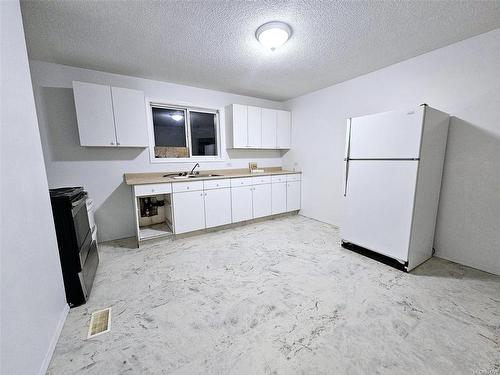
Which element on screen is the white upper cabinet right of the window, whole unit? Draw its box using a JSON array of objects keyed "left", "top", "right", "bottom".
[{"left": 226, "top": 104, "right": 292, "bottom": 150}]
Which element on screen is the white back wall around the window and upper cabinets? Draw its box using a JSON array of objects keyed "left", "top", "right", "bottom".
[{"left": 30, "top": 61, "right": 283, "bottom": 241}]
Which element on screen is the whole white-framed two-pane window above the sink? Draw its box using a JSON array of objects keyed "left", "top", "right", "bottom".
[{"left": 147, "top": 103, "right": 220, "bottom": 161}]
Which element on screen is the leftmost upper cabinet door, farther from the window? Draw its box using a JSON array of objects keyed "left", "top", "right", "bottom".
[{"left": 73, "top": 81, "right": 116, "bottom": 147}]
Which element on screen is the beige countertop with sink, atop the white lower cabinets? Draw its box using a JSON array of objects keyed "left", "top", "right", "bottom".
[{"left": 123, "top": 167, "right": 302, "bottom": 185}]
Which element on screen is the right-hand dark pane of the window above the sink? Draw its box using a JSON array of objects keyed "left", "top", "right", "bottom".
[{"left": 189, "top": 112, "right": 217, "bottom": 156}]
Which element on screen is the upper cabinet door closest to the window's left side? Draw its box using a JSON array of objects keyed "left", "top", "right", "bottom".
[{"left": 111, "top": 87, "right": 149, "bottom": 147}]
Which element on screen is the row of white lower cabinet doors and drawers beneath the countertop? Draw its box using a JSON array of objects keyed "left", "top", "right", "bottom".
[{"left": 170, "top": 174, "right": 301, "bottom": 234}]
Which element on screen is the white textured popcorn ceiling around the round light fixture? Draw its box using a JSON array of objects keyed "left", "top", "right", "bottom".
[{"left": 22, "top": 0, "right": 500, "bottom": 100}]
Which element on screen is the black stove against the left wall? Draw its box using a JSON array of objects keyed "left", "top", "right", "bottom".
[{"left": 50, "top": 187, "right": 99, "bottom": 307}]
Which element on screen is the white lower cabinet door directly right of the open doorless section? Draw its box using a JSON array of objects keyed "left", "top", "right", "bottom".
[{"left": 172, "top": 191, "right": 205, "bottom": 234}]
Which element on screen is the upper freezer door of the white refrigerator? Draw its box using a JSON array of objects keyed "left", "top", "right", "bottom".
[{"left": 349, "top": 107, "right": 424, "bottom": 159}]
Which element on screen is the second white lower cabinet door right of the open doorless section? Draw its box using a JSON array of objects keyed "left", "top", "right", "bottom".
[{"left": 204, "top": 188, "right": 231, "bottom": 228}]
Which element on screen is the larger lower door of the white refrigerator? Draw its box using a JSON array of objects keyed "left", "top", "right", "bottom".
[{"left": 342, "top": 160, "right": 419, "bottom": 262}]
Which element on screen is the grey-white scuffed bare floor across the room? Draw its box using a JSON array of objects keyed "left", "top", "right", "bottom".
[{"left": 48, "top": 216, "right": 500, "bottom": 375}]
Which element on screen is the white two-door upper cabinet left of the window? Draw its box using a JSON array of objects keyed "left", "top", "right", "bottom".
[{"left": 73, "top": 81, "right": 149, "bottom": 147}]
